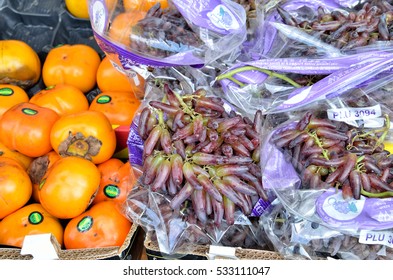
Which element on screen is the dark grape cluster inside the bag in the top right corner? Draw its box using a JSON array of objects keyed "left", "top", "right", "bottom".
[{"left": 277, "top": 0, "right": 393, "bottom": 52}]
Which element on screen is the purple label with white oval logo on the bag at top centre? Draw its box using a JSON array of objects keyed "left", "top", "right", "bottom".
[{"left": 172, "top": 0, "right": 245, "bottom": 35}]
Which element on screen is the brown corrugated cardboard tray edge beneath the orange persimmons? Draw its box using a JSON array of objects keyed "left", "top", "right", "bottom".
[{"left": 0, "top": 224, "right": 143, "bottom": 260}]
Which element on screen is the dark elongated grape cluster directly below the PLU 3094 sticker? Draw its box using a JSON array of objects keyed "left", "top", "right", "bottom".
[{"left": 272, "top": 112, "right": 393, "bottom": 199}]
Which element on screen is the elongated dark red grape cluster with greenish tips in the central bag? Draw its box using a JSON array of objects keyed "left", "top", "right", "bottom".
[{"left": 138, "top": 84, "right": 268, "bottom": 225}]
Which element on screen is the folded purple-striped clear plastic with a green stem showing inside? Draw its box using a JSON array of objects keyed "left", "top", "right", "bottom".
[{"left": 216, "top": 51, "right": 393, "bottom": 113}]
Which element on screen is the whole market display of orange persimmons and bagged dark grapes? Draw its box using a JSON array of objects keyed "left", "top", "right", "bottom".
[{"left": 0, "top": 0, "right": 393, "bottom": 260}]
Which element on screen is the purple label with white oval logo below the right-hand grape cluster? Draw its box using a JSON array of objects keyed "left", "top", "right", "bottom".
[{"left": 316, "top": 188, "right": 393, "bottom": 230}]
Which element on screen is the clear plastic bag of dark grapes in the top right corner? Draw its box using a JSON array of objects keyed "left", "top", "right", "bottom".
[{"left": 253, "top": 0, "right": 393, "bottom": 58}]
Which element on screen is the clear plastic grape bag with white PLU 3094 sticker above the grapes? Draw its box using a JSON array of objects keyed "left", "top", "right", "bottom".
[{"left": 261, "top": 62, "right": 393, "bottom": 234}]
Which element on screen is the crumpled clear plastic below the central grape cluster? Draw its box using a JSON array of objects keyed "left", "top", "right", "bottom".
[{"left": 124, "top": 180, "right": 267, "bottom": 255}]
